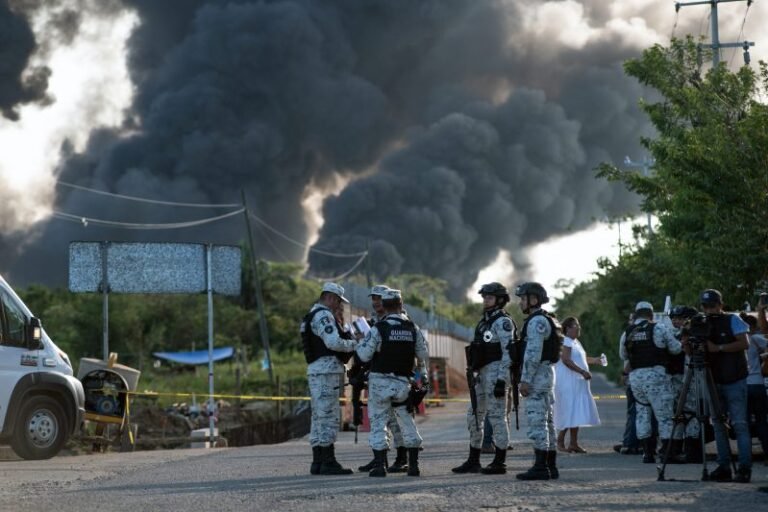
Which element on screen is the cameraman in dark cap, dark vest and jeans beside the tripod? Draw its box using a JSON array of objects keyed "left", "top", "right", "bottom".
[{"left": 684, "top": 289, "right": 752, "bottom": 483}]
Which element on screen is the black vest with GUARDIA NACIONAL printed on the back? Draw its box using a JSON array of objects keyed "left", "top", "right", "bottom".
[{"left": 371, "top": 317, "right": 416, "bottom": 377}]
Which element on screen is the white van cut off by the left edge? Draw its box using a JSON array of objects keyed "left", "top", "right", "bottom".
[{"left": 0, "top": 276, "right": 85, "bottom": 459}]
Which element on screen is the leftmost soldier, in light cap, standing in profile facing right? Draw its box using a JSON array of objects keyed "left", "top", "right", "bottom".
[{"left": 301, "top": 283, "right": 357, "bottom": 475}]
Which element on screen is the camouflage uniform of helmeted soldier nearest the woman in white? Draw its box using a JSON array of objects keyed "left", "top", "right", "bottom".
[{"left": 520, "top": 315, "right": 557, "bottom": 451}]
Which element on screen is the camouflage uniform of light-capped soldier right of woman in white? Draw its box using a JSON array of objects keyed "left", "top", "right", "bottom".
[{"left": 619, "top": 318, "right": 682, "bottom": 440}]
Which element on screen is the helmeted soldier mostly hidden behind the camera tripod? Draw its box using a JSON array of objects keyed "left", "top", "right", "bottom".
[{"left": 667, "top": 306, "right": 702, "bottom": 464}]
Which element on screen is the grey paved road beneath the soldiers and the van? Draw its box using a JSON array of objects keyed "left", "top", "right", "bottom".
[{"left": 0, "top": 375, "right": 768, "bottom": 512}]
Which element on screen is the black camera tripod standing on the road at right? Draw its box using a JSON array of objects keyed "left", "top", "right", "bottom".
[{"left": 658, "top": 343, "right": 736, "bottom": 482}]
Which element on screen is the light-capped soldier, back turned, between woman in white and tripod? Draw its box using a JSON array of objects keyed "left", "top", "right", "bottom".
[{"left": 619, "top": 301, "right": 682, "bottom": 464}]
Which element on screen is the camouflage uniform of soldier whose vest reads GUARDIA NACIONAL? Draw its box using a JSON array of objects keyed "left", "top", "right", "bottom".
[{"left": 357, "top": 314, "right": 429, "bottom": 450}]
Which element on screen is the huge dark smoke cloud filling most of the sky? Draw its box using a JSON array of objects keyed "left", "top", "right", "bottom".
[{"left": 0, "top": 0, "right": 696, "bottom": 295}]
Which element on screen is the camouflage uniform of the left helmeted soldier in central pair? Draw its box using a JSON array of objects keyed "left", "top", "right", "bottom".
[{"left": 467, "top": 313, "right": 515, "bottom": 449}]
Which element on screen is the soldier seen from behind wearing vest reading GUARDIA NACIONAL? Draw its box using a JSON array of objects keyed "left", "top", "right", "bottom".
[{"left": 355, "top": 289, "right": 429, "bottom": 476}]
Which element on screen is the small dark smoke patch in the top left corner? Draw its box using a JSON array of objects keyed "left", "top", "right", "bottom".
[{"left": 0, "top": 0, "right": 51, "bottom": 121}]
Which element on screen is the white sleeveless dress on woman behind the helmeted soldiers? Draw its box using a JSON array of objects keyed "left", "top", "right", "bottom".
[{"left": 554, "top": 336, "right": 600, "bottom": 430}]
